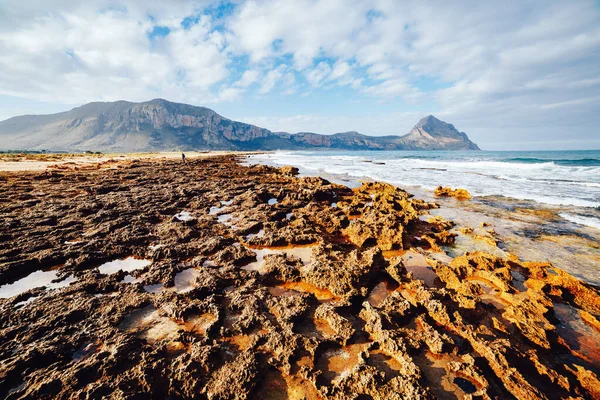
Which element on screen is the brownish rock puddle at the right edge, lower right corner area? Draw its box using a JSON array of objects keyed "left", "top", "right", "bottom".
[{"left": 554, "top": 303, "right": 600, "bottom": 365}]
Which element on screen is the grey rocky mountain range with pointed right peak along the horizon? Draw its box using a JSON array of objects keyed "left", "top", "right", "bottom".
[{"left": 0, "top": 99, "right": 479, "bottom": 152}]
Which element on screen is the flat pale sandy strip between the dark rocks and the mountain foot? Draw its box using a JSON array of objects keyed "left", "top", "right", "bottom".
[{"left": 0, "top": 151, "right": 261, "bottom": 172}]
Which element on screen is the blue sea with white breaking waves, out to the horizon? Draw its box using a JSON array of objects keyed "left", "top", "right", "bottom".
[{"left": 252, "top": 150, "right": 600, "bottom": 229}]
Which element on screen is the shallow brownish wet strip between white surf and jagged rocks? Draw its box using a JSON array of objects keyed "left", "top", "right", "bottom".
[{"left": 244, "top": 153, "right": 600, "bottom": 287}]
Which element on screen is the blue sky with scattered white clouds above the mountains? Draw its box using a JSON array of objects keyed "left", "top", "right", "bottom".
[{"left": 0, "top": 0, "right": 600, "bottom": 150}]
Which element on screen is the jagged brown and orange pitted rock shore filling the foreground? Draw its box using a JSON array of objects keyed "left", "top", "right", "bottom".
[{"left": 0, "top": 156, "right": 600, "bottom": 399}]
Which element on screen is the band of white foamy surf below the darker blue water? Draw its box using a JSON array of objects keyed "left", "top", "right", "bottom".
[{"left": 251, "top": 153, "right": 600, "bottom": 208}]
